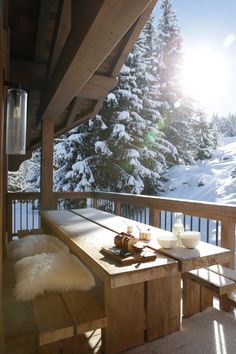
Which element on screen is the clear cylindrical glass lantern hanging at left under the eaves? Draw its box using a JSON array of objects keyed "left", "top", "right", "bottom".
[{"left": 6, "top": 88, "right": 27, "bottom": 155}]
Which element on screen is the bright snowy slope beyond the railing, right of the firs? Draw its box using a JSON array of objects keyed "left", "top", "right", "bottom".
[{"left": 161, "top": 136, "right": 236, "bottom": 204}]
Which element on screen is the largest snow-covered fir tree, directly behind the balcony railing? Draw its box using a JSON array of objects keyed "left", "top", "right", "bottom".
[{"left": 55, "top": 18, "right": 177, "bottom": 194}]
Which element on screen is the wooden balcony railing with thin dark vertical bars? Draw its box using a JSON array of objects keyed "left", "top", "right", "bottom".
[{"left": 7, "top": 192, "right": 236, "bottom": 261}]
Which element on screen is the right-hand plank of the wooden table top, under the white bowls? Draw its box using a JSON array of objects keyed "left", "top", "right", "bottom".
[{"left": 73, "top": 208, "right": 230, "bottom": 272}]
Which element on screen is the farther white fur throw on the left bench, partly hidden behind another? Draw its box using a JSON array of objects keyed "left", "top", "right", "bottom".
[{"left": 8, "top": 234, "right": 69, "bottom": 261}]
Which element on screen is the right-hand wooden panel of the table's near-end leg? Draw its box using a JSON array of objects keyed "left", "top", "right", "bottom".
[{"left": 146, "top": 273, "right": 181, "bottom": 341}]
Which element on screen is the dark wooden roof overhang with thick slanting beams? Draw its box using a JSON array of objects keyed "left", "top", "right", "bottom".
[{"left": 8, "top": 0, "right": 156, "bottom": 167}]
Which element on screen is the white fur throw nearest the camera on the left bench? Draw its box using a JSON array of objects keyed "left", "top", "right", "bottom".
[{"left": 14, "top": 252, "right": 95, "bottom": 301}]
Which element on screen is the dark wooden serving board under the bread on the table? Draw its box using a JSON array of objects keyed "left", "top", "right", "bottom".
[{"left": 101, "top": 246, "right": 157, "bottom": 265}]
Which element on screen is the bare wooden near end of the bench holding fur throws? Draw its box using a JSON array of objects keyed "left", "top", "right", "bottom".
[{"left": 33, "top": 289, "right": 107, "bottom": 354}]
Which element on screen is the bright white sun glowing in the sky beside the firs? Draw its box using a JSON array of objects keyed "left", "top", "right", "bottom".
[{"left": 181, "top": 49, "right": 229, "bottom": 110}]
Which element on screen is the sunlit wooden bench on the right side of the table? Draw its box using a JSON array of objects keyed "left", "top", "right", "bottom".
[{"left": 182, "top": 265, "right": 236, "bottom": 317}]
